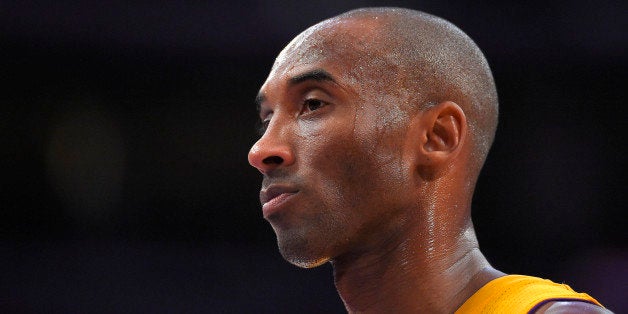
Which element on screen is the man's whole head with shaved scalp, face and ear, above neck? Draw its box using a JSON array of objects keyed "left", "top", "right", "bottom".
[{"left": 249, "top": 8, "right": 497, "bottom": 267}]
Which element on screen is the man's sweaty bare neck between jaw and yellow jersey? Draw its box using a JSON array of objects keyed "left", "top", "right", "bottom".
[{"left": 332, "top": 219, "right": 501, "bottom": 313}]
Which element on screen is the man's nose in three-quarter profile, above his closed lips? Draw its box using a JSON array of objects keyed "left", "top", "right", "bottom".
[{"left": 248, "top": 128, "right": 294, "bottom": 174}]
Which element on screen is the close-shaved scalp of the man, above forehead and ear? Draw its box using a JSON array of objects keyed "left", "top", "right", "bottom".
[{"left": 273, "top": 8, "right": 498, "bottom": 176}]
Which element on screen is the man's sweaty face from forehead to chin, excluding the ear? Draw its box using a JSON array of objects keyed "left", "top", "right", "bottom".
[{"left": 249, "top": 19, "right": 416, "bottom": 267}]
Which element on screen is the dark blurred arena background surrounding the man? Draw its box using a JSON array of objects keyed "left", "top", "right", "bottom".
[{"left": 0, "top": 1, "right": 628, "bottom": 313}]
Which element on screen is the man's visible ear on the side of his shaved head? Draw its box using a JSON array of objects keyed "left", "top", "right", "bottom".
[{"left": 419, "top": 101, "right": 467, "bottom": 168}]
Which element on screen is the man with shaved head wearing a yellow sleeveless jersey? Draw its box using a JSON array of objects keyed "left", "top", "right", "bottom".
[{"left": 248, "top": 8, "right": 606, "bottom": 313}]
